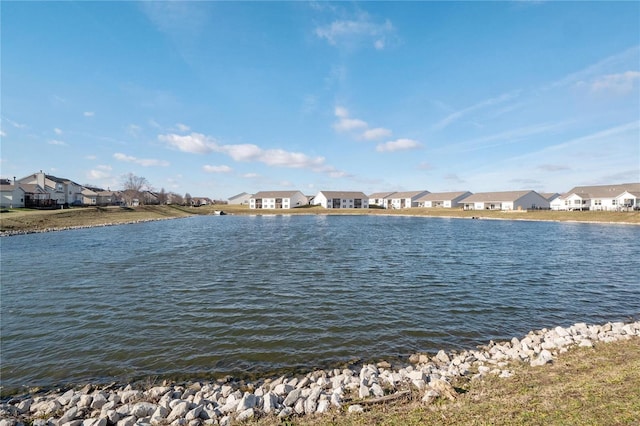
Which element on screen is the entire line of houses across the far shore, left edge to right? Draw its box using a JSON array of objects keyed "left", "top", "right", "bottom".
[{"left": 0, "top": 171, "right": 640, "bottom": 211}]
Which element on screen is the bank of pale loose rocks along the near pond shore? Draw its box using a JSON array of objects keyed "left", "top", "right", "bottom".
[{"left": 0, "top": 321, "right": 640, "bottom": 426}]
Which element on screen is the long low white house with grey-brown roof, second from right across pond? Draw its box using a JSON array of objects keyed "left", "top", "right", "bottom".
[{"left": 460, "top": 191, "right": 549, "bottom": 210}]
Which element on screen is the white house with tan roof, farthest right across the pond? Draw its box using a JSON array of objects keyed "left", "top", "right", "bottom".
[{"left": 552, "top": 183, "right": 640, "bottom": 211}]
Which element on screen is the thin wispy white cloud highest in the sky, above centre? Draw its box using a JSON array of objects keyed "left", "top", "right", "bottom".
[{"left": 315, "top": 13, "right": 395, "bottom": 50}]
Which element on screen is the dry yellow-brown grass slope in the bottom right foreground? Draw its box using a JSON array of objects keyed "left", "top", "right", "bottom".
[{"left": 258, "top": 338, "right": 640, "bottom": 426}]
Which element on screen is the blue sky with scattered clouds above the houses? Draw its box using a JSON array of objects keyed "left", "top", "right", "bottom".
[{"left": 0, "top": 1, "right": 640, "bottom": 199}]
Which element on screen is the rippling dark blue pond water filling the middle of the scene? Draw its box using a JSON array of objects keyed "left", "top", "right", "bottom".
[{"left": 0, "top": 215, "right": 640, "bottom": 389}]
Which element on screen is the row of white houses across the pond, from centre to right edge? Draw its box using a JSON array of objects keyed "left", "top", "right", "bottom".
[{"left": 235, "top": 183, "right": 640, "bottom": 211}]
